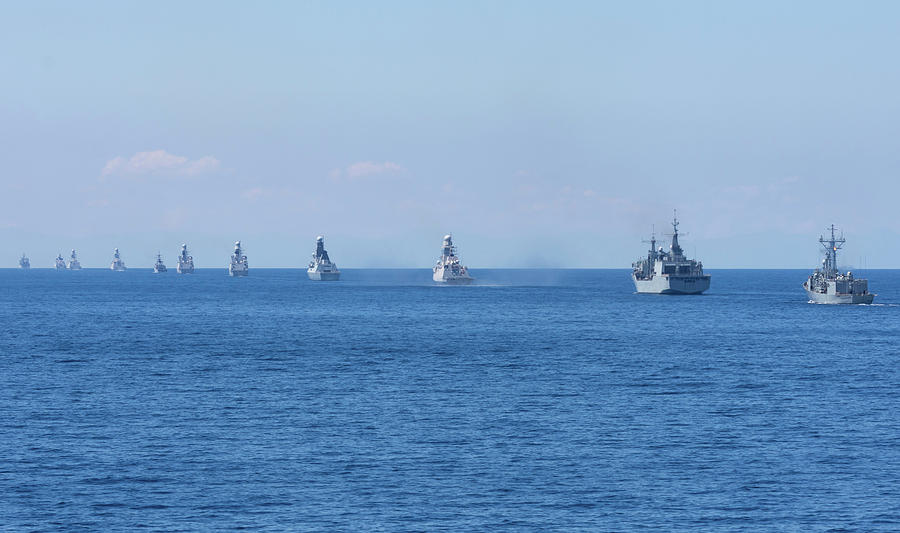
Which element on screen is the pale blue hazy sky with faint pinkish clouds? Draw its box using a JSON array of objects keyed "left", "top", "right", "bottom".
[{"left": 0, "top": 1, "right": 900, "bottom": 269}]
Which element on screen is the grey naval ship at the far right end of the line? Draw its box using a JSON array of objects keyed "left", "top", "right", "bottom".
[{"left": 803, "top": 224, "right": 875, "bottom": 304}]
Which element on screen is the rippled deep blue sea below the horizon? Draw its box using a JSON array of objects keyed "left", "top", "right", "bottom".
[{"left": 0, "top": 269, "right": 900, "bottom": 532}]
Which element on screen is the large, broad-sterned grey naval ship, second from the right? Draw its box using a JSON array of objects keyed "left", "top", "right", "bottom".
[{"left": 631, "top": 216, "right": 710, "bottom": 294}]
